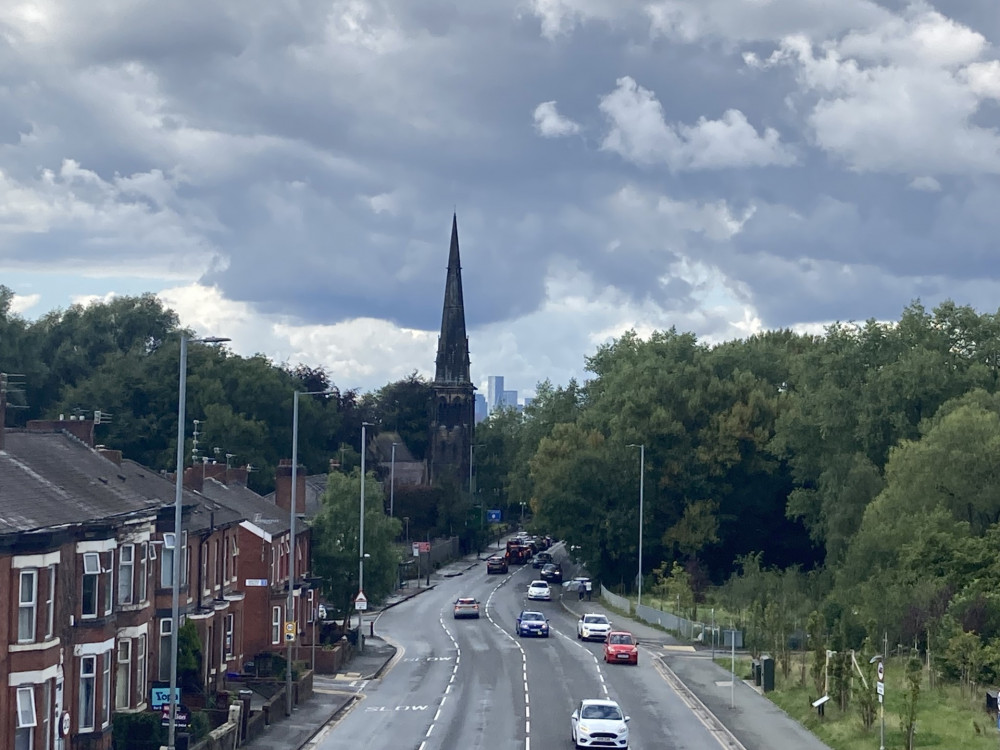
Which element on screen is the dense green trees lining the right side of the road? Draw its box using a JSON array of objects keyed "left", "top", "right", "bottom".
[{"left": 477, "top": 303, "right": 1000, "bottom": 692}]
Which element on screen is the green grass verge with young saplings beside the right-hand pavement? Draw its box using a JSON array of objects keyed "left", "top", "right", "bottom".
[{"left": 716, "top": 655, "right": 1000, "bottom": 750}]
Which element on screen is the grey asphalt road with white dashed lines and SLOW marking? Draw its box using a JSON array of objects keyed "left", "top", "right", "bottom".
[{"left": 319, "top": 548, "right": 720, "bottom": 750}]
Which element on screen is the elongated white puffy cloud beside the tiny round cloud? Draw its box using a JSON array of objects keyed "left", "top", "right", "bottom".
[{"left": 600, "top": 76, "right": 795, "bottom": 171}]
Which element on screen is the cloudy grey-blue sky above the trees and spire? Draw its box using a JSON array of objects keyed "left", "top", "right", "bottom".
[{"left": 0, "top": 0, "right": 1000, "bottom": 394}]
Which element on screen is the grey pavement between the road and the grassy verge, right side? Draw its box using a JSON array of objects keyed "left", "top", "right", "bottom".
[{"left": 562, "top": 590, "right": 830, "bottom": 750}]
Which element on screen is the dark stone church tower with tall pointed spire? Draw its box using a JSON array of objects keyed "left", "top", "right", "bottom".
[{"left": 428, "top": 216, "right": 476, "bottom": 490}]
